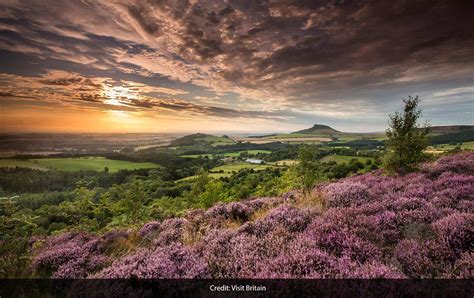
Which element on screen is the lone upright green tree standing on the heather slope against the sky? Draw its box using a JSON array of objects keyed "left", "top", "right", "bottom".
[{"left": 384, "top": 96, "right": 429, "bottom": 173}]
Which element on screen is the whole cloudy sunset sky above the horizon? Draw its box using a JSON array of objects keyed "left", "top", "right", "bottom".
[{"left": 0, "top": 0, "right": 474, "bottom": 133}]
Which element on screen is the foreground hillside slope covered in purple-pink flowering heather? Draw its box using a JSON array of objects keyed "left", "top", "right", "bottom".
[{"left": 32, "top": 153, "right": 474, "bottom": 278}]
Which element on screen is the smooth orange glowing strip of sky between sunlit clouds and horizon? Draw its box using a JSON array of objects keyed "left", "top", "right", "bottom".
[{"left": 0, "top": 106, "right": 288, "bottom": 133}]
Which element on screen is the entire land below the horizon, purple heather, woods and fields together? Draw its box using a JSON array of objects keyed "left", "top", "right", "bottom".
[{"left": 0, "top": 99, "right": 474, "bottom": 278}]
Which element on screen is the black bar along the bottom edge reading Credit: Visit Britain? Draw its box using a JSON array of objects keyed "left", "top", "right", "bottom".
[{"left": 0, "top": 279, "right": 474, "bottom": 298}]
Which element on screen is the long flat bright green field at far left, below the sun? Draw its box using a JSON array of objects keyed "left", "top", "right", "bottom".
[{"left": 0, "top": 157, "right": 158, "bottom": 172}]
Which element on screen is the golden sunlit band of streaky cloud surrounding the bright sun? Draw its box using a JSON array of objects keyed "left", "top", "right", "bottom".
[{"left": 0, "top": 70, "right": 285, "bottom": 119}]
